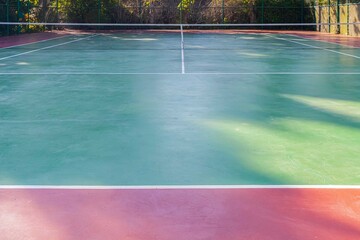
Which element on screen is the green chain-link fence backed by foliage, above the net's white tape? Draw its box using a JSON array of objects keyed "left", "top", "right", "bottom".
[{"left": 0, "top": 0, "right": 315, "bottom": 35}]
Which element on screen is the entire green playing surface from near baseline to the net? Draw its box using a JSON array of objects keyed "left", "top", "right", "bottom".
[{"left": 0, "top": 32, "right": 360, "bottom": 186}]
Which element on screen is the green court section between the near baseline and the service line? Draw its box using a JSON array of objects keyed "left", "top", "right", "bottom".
[{"left": 0, "top": 75, "right": 360, "bottom": 185}]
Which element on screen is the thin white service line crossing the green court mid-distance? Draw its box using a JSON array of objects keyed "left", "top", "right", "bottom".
[{"left": 0, "top": 72, "right": 360, "bottom": 75}]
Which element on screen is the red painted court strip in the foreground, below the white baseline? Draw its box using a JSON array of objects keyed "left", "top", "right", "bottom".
[{"left": 0, "top": 189, "right": 360, "bottom": 240}]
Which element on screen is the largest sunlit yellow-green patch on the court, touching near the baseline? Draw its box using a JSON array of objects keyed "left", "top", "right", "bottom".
[{"left": 203, "top": 118, "right": 360, "bottom": 184}]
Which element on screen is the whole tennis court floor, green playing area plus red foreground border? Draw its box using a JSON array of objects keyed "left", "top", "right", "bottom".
[{"left": 0, "top": 25, "right": 360, "bottom": 240}]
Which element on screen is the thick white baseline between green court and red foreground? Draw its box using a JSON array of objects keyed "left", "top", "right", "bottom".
[{"left": 0, "top": 185, "right": 360, "bottom": 190}]
